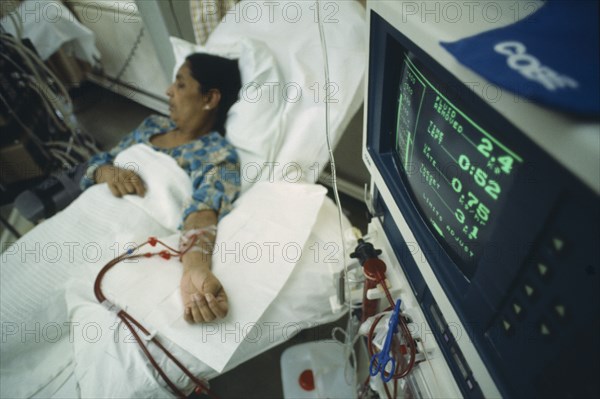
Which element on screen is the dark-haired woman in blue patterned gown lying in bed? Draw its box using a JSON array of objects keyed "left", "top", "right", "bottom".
[{"left": 81, "top": 53, "right": 241, "bottom": 322}]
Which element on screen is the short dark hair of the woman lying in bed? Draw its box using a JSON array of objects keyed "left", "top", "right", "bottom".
[{"left": 186, "top": 53, "right": 242, "bottom": 136}]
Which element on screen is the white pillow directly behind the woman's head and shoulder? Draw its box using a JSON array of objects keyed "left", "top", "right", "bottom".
[{"left": 171, "top": 37, "right": 283, "bottom": 192}]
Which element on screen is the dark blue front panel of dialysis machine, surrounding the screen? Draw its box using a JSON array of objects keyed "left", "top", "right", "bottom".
[{"left": 367, "top": 12, "right": 600, "bottom": 397}]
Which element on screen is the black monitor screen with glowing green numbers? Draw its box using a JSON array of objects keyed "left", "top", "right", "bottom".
[{"left": 391, "top": 52, "right": 524, "bottom": 279}]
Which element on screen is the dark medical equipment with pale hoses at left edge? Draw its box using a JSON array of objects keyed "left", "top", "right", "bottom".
[{"left": 0, "top": 31, "right": 98, "bottom": 192}]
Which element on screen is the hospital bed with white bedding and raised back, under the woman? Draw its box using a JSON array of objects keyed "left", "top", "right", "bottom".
[{"left": 0, "top": 1, "right": 366, "bottom": 397}]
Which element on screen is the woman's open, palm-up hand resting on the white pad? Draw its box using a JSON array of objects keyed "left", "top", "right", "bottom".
[{"left": 181, "top": 267, "right": 229, "bottom": 323}]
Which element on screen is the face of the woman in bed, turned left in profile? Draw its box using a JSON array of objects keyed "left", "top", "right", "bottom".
[{"left": 167, "top": 62, "right": 206, "bottom": 124}]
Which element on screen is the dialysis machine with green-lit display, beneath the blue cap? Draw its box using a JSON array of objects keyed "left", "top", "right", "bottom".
[{"left": 363, "top": 1, "right": 600, "bottom": 397}]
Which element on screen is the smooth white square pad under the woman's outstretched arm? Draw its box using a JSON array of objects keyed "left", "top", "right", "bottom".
[{"left": 98, "top": 178, "right": 325, "bottom": 372}]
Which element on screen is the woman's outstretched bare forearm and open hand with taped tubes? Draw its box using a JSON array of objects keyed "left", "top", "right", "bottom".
[{"left": 181, "top": 210, "right": 229, "bottom": 323}]
